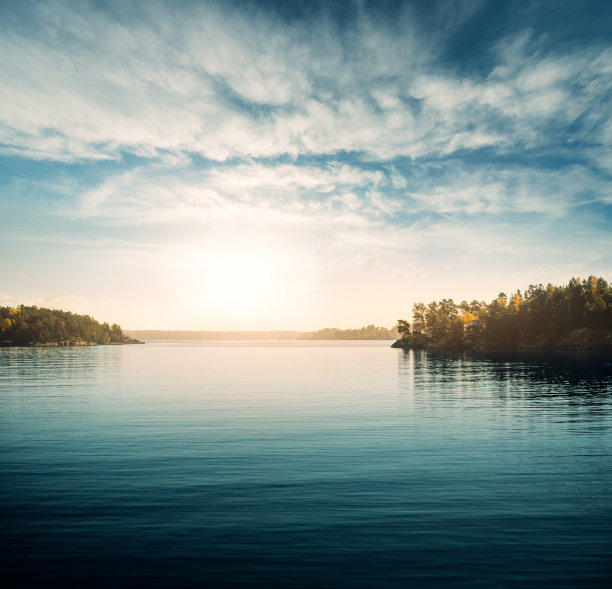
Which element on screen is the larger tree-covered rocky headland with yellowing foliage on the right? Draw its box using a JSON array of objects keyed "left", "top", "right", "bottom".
[{"left": 392, "top": 276, "right": 612, "bottom": 352}]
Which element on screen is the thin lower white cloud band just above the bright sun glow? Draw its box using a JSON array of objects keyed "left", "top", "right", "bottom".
[{"left": 53, "top": 146, "right": 609, "bottom": 280}]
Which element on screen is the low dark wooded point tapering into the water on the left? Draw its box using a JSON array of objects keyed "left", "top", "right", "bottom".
[{"left": 0, "top": 305, "right": 140, "bottom": 346}]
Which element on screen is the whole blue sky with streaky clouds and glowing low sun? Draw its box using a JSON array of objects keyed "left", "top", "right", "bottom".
[{"left": 0, "top": 0, "right": 612, "bottom": 330}]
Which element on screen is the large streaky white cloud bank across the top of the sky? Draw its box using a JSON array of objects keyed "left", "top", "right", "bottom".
[{"left": 0, "top": 3, "right": 612, "bottom": 167}]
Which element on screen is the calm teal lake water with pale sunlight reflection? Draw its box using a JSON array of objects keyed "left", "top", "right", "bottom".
[{"left": 0, "top": 342, "right": 612, "bottom": 588}]
